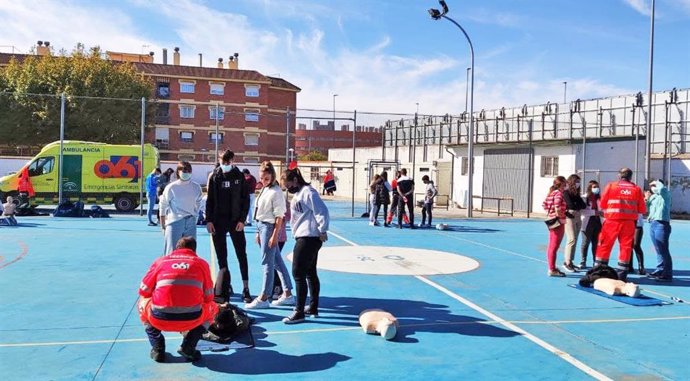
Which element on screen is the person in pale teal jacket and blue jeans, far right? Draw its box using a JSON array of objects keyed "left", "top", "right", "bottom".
[{"left": 645, "top": 180, "right": 673, "bottom": 282}]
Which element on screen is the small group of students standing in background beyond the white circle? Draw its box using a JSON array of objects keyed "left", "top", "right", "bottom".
[{"left": 369, "top": 168, "right": 438, "bottom": 229}]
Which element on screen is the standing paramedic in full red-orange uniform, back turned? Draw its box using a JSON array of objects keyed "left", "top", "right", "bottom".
[{"left": 595, "top": 168, "right": 647, "bottom": 282}]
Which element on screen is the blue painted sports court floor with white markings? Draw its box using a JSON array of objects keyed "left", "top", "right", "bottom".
[{"left": 0, "top": 201, "right": 690, "bottom": 380}]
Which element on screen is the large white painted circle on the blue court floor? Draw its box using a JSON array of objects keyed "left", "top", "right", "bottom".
[{"left": 288, "top": 246, "right": 479, "bottom": 275}]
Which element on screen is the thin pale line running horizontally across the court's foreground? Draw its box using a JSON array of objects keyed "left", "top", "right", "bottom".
[{"left": 0, "top": 316, "right": 690, "bottom": 348}]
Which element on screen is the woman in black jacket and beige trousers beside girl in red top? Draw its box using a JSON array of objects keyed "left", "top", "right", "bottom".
[{"left": 563, "top": 174, "right": 587, "bottom": 272}]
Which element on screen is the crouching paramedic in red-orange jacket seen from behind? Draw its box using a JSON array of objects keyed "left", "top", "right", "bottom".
[{"left": 139, "top": 237, "right": 218, "bottom": 362}]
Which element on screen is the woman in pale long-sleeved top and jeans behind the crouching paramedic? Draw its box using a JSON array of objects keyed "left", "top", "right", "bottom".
[{"left": 158, "top": 161, "right": 202, "bottom": 255}]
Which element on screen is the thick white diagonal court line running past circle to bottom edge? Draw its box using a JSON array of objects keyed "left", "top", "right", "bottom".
[{"left": 331, "top": 232, "right": 612, "bottom": 381}]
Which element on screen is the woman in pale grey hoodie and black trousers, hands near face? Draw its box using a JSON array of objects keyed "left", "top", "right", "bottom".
[{"left": 282, "top": 168, "right": 330, "bottom": 324}]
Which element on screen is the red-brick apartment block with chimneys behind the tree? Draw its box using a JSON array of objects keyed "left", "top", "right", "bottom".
[{"left": 0, "top": 44, "right": 300, "bottom": 163}]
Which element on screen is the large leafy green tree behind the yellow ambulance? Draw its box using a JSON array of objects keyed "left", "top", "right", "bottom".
[{"left": 0, "top": 45, "right": 155, "bottom": 146}]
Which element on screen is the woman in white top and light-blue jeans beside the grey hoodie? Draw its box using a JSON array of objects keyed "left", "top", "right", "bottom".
[{"left": 244, "top": 161, "right": 295, "bottom": 310}]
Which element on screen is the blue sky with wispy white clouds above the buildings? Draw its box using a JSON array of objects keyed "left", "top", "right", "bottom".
[{"left": 0, "top": 0, "right": 690, "bottom": 114}]
